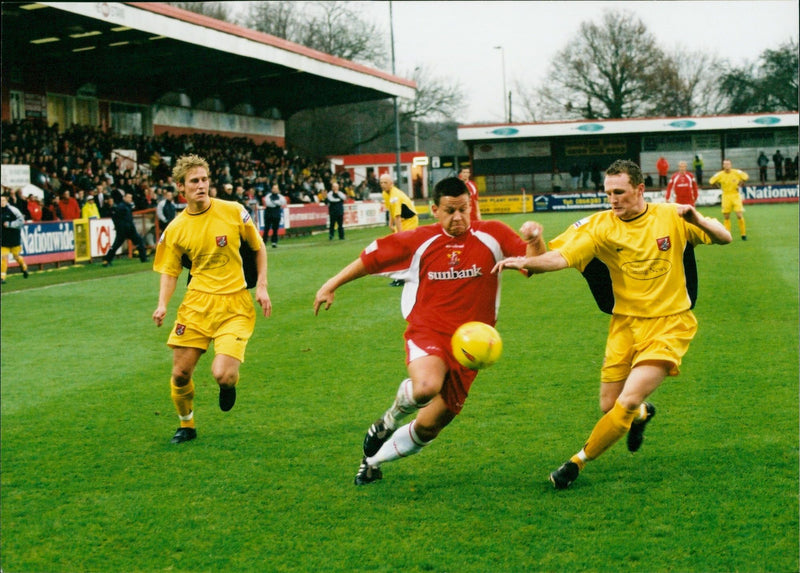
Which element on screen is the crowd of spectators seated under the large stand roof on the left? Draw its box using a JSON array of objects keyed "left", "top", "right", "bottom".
[{"left": 2, "top": 120, "right": 371, "bottom": 221}]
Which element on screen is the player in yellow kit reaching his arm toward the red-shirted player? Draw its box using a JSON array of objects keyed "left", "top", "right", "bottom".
[{"left": 493, "top": 160, "right": 731, "bottom": 489}]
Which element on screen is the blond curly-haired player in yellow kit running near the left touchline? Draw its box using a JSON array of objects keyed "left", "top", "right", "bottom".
[{"left": 153, "top": 155, "right": 272, "bottom": 444}]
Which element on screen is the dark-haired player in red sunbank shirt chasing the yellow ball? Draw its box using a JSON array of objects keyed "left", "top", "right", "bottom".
[{"left": 314, "top": 177, "right": 545, "bottom": 485}]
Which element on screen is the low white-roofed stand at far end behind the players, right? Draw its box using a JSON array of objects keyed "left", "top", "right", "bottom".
[{"left": 458, "top": 112, "right": 798, "bottom": 195}]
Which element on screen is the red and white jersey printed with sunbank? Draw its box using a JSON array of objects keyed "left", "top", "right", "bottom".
[{"left": 361, "top": 221, "right": 527, "bottom": 335}]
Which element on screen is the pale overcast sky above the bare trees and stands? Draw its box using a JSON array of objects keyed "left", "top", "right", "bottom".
[{"left": 356, "top": 0, "right": 800, "bottom": 123}]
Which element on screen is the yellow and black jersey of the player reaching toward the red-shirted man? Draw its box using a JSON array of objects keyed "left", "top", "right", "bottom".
[{"left": 549, "top": 203, "right": 711, "bottom": 318}]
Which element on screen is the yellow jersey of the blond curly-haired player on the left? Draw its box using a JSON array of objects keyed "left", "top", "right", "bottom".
[{"left": 153, "top": 199, "right": 264, "bottom": 294}]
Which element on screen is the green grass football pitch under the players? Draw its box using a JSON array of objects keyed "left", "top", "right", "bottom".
[{"left": 0, "top": 205, "right": 800, "bottom": 573}]
